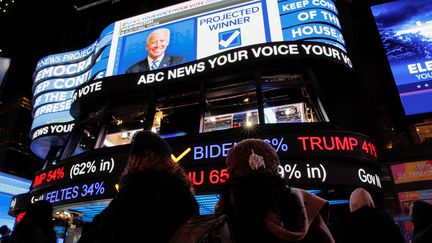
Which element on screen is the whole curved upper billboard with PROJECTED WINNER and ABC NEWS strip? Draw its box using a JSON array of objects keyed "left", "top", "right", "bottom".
[{"left": 31, "top": 0, "right": 352, "bottom": 157}]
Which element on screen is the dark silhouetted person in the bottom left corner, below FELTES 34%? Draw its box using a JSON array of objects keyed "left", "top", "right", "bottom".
[{"left": 9, "top": 200, "right": 57, "bottom": 243}]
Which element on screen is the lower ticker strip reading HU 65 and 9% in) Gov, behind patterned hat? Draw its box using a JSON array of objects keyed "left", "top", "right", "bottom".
[{"left": 186, "top": 159, "right": 382, "bottom": 192}]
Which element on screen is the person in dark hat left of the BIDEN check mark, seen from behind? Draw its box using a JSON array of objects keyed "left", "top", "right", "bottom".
[{"left": 90, "top": 131, "right": 199, "bottom": 243}]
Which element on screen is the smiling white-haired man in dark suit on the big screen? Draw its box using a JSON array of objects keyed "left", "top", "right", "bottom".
[{"left": 126, "top": 28, "right": 184, "bottom": 73}]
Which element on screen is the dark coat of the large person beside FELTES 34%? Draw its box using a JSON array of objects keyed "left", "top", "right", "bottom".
[{"left": 92, "top": 170, "right": 199, "bottom": 243}]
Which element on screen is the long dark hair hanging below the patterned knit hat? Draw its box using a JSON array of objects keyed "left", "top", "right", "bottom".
[{"left": 221, "top": 174, "right": 305, "bottom": 240}]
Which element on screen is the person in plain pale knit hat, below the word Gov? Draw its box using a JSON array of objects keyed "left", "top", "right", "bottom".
[{"left": 343, "top": 187, "right": 405, "bottom": 243}]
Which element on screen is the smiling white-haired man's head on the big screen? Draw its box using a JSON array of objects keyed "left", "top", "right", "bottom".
[{"left": 146, "top": 28, "right": 170, "bottom": 59}]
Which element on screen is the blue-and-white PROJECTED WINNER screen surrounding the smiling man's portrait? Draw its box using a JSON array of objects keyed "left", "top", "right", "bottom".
[{"left": 107, "top": 0, "right": 345, "bottom": 75}]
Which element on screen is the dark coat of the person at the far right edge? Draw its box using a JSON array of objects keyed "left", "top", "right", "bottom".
[{"left": 411, "top": 201, "right": 432, "bottom": 243}]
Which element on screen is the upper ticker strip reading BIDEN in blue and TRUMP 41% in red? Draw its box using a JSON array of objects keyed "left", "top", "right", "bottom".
[{"left": 169, "top": 128, "right": 377, "bottom": 166}]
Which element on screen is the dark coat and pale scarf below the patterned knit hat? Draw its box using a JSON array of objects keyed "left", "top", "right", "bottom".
[{"left": 218, "top": 175, "right": 335, "bottom": 243}]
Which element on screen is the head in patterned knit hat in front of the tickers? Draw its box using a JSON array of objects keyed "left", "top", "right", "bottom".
[{"left": 226, "top": 138, "right": 280, "bottom": 177}]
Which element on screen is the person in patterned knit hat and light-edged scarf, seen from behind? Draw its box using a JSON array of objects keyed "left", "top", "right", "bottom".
[{"left": 216, "top": 139, "right": 334, "bottom": 243}]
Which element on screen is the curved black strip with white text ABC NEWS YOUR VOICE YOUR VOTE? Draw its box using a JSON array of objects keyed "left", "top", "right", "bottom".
[{"left": 71, "top": 42, "right": 351, "bottom": 110}]
